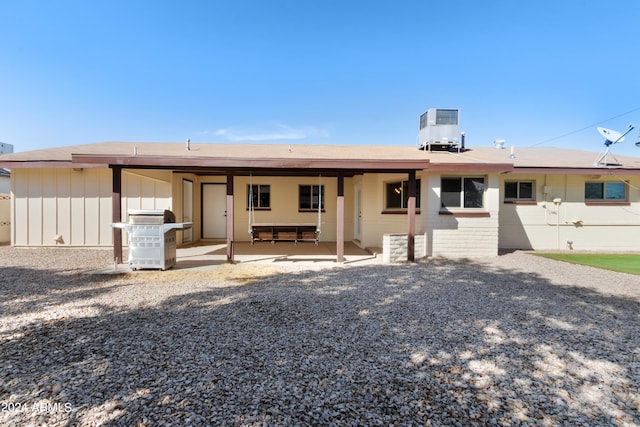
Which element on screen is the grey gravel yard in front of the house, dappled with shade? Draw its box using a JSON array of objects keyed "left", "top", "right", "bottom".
[{"left": 0, "top": 247, "right": 640, "bottom": 426}]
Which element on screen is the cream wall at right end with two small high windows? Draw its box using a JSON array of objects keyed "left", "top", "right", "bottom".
[{"left": 500, "top": 174, "right": 640, "bottom": 251}]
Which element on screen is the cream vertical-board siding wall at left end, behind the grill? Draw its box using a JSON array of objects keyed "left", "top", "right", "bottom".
[{"left": 11, "top": 168, "right": 171, "bottom": 247}]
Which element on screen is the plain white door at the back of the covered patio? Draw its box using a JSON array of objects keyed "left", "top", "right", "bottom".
[{"left": 202, "top": 184, "right": 227, "bottom": 239}]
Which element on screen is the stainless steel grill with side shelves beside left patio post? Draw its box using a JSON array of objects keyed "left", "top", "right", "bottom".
[{"left": 111, "top": 209, "right": 193, "bottom": 270}]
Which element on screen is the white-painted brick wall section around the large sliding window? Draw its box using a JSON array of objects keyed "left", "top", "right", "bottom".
[{"left": 426, "top": 173, "right": 500, "bottom": 258}]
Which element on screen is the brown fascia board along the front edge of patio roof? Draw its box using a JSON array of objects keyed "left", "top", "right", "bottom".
[{"left": 71, "top": 154, "right": 429, "bottom": 170}]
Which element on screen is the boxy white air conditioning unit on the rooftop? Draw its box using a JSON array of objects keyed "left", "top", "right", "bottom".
[{"left": 418, "top": 108, "right": 460, "bottom": 151}]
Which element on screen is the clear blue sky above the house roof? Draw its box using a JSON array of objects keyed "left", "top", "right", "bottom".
[{"left": 0, "top": 0, "right": 640, "bottom": 156}]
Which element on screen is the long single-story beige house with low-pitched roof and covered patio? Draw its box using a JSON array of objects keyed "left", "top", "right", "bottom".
[{"left": 0, "top": 142, "right": 640, "bottom": 260}]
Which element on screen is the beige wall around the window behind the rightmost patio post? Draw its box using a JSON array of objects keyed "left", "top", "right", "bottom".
[{"left": 358, "top": 173, "right": 429, "bottom": 248}]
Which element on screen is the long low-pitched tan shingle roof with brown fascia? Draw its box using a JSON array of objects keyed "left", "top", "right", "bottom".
[{"left": 0, "top": 142, "right": 640, "bottom": 173}]
